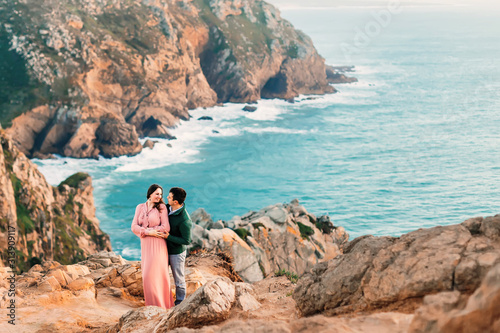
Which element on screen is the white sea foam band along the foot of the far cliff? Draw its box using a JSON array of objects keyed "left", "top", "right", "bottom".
[{"left": 35, "top": 74, "right": 378, "bottom": 184}]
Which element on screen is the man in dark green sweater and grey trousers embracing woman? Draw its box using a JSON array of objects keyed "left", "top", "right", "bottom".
[{"left": 166, "top": 187, "right": 193, "bottom": 305}]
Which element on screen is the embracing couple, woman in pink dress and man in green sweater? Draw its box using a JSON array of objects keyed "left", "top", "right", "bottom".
[{"left": 132, "top": 184, "right": 192, "bottom": 309}]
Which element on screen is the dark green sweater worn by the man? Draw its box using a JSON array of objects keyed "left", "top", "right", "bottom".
[{"left": 166, "top": 205, "right": 193, "bottom": 254}]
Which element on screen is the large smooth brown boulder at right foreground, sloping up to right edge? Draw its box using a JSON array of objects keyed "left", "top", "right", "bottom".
[{"left": 293, "top": 215, "right": 500, "bottom": 316}]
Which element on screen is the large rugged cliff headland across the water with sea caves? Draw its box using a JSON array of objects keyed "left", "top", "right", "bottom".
[{"left": 0, "top": 0, "right": 334, "bottom": 158}]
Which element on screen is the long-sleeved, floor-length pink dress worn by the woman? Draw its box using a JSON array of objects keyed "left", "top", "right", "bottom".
[{"left": 132, "top": 203, "right": 174, "bottom": 309}]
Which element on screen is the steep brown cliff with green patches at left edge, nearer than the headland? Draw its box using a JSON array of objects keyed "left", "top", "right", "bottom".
[{"left": 0, "top": 129, "right": 111, "bottom": 271}]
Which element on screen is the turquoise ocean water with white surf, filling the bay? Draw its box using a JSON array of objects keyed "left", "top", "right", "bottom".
[{"left": 35, "top": 1, "right": 500, "bottom": 259}]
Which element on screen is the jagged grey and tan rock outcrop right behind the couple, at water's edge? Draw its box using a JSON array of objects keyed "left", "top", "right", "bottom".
[{"left": 188, "top": 200, "right": 349, "bottom": 282}]
